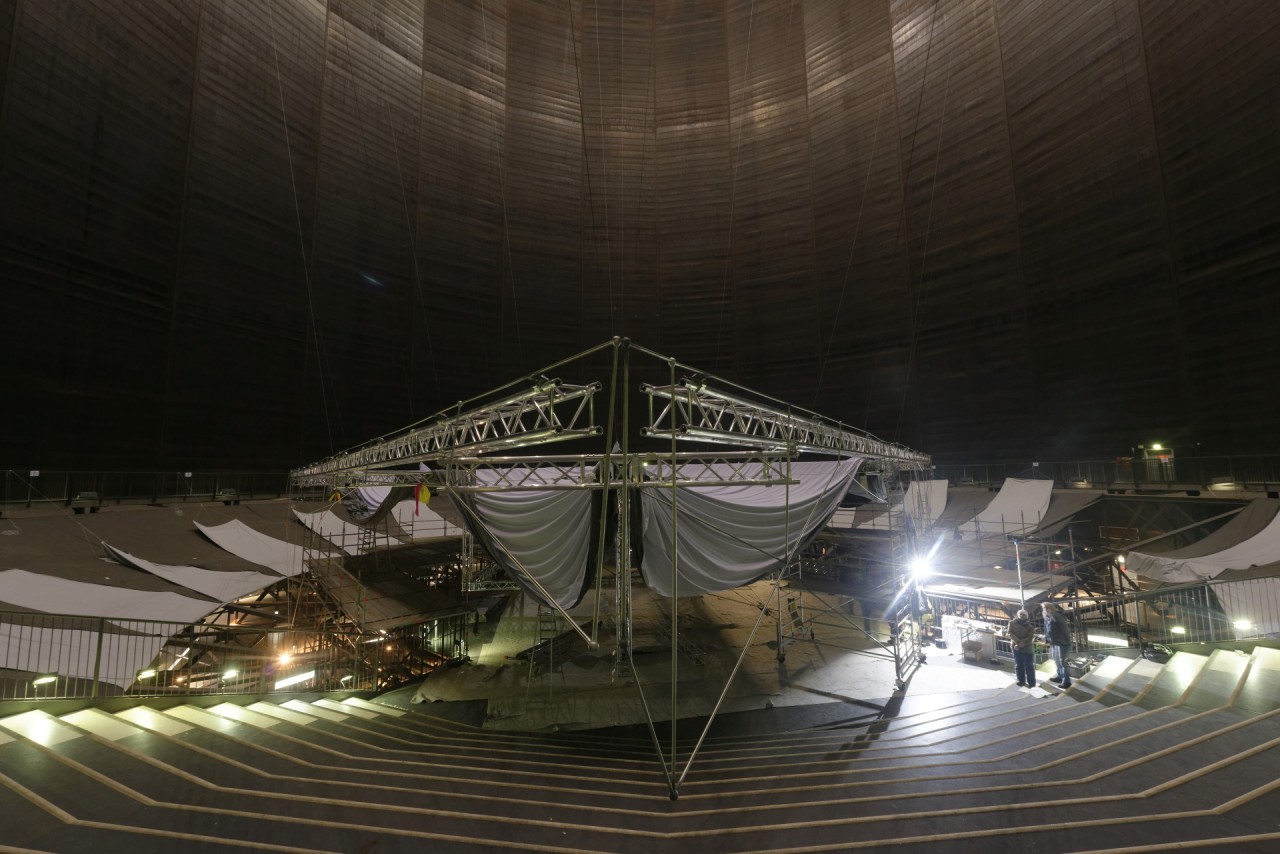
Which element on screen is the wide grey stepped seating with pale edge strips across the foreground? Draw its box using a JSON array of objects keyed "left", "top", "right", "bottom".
[{"left": 0, "top": 648, "right": 1280, "bottom": 853}]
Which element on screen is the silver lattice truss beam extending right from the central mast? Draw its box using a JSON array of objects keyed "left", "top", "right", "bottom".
[{"left": 640, "top": 380, "right": 931, "bottom": 466}]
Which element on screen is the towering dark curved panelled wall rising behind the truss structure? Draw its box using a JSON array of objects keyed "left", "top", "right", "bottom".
[{"left": 0, "top": 0, "right": 1280, "bottom": 470}]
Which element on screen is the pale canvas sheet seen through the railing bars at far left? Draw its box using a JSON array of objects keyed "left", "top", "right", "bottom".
[{"left": 0, "top": 621, "right": 168, "bottom": 688}]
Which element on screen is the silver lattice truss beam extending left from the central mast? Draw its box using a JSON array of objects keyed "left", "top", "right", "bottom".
[{"left": 289, "top": 380, "right": 603, "bottom": 487}]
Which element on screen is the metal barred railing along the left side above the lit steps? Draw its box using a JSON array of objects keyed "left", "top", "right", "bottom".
[{"left": 0, "top": 612, "right": 465, "bottom": 700}]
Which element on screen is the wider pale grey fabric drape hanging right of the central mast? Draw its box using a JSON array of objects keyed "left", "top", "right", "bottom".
[{"left": 640, "top": 457, "right": 863, "bottom": 597}]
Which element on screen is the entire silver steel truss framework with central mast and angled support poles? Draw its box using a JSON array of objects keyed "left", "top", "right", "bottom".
[{"left": 291, "top": 338, "right": 931, "bottom": 799}]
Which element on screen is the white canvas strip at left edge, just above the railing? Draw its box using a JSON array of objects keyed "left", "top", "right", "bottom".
[{"left": 0, "top": 570, "right": 220, "bottom": 624}]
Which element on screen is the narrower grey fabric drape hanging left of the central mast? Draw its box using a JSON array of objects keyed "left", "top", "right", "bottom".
[{"left": 453, "top": 471, "right": 596, "bottom": 608}]
